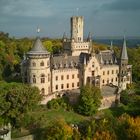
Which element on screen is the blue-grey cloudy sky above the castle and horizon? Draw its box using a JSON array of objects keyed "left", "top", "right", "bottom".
[{"left": 0, "top": 0, "right": 140, "bottom": 38}]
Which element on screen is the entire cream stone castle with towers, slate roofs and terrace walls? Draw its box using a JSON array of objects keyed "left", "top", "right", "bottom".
[{"left": 21, "top": 16, "right": 132, "bottom": 108}]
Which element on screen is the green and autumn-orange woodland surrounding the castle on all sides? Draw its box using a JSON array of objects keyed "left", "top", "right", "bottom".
[{"left": 0, "top": 32, "right": 140, "bottom": 140}]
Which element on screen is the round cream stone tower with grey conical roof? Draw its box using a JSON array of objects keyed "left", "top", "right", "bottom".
[{"left": 26, "top": 37, "right": 51, "bottom": 95}]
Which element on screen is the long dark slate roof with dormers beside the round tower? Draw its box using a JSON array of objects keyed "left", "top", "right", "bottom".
[{"left": 52, "top": 56, "right": 79, "bottom": 69}]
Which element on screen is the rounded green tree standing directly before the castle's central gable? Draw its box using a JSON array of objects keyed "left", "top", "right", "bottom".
[{"left": 77, "top": 85, "right": 102, "bottom": 116}]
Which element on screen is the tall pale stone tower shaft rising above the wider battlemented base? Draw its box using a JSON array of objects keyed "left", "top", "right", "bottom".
[{"left": 71, "top": 16, "right": 84, "bottom": 42}]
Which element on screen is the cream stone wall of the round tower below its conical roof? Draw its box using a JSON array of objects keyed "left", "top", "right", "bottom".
[{"left": 27, "top": 58, "right": 51, "bottom": 95}]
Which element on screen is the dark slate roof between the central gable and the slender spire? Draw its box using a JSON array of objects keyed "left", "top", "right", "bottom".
[{"left": 96, "top": 50, "right": 117, "bottom": 65}]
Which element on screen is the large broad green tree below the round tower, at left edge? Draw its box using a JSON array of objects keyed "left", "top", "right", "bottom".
[{"left": 0, "top": 82, "right": 42, "bottom": 127}]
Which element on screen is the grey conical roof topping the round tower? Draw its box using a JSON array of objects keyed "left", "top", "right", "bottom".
[{"left": 27, "top": 37, "right": 49, "bottom": 55}]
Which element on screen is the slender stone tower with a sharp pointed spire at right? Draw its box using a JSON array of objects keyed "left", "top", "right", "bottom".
[{"left": 119, "top": 37, "right": 128, "bottom": 90}]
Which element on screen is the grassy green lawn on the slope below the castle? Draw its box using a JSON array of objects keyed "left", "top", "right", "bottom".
[{"left": 30, "top": 108, "right": 90, "bottom": 126}]
